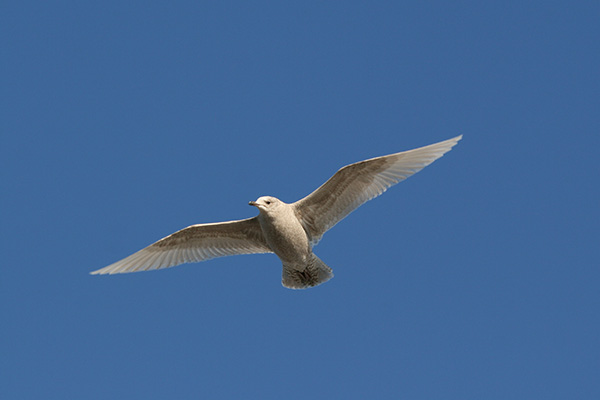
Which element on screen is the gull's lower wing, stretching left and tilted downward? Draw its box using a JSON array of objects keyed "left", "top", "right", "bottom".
[{"left": 92, "top": 217, "right": 272, "bottom": 274}]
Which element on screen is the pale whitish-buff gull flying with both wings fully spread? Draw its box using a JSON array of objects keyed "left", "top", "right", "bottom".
[{"left": 91, "top": 135, "right": 462, "bottom": 289}]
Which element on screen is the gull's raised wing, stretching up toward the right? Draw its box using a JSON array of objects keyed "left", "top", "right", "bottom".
[{"left": 293, "top": 135, "right": 462, "bottom": 244}]
